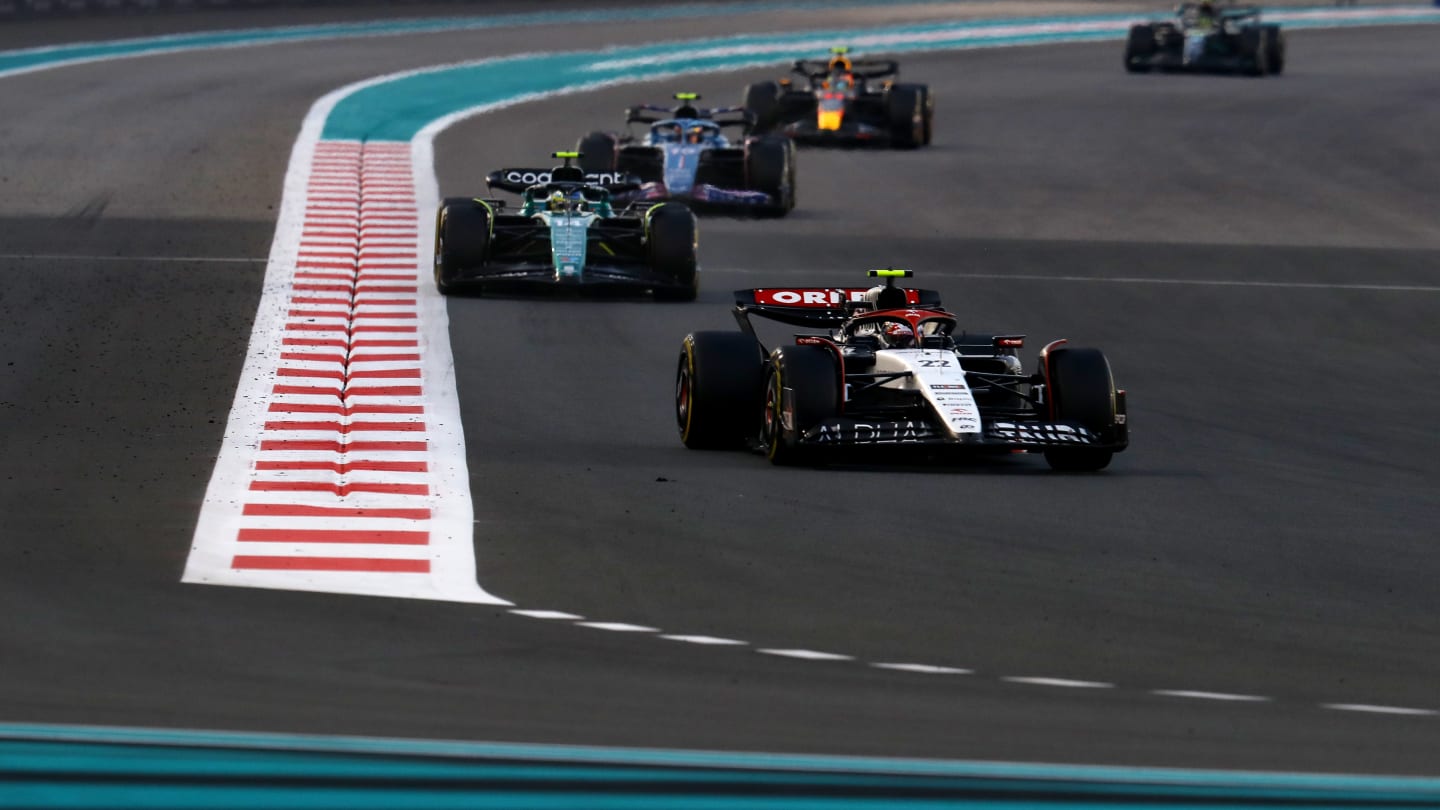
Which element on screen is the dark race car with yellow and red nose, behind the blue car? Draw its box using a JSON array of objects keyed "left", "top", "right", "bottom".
[{"left": 744, "top": 48, "right": 935, "bottom": 148}]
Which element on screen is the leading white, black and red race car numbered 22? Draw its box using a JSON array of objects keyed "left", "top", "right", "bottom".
[{"left": 675, "top": 270, "right": 1129, "bottom": 470}]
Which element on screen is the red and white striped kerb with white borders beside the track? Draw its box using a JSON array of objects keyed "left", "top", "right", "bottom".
[{"left": 184, "top": 141, "right": 498, "bottom": 601}]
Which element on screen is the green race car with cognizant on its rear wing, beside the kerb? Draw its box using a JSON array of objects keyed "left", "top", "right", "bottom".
[{"left": 435, "top": 151, "right": 700, "bottom": 301}]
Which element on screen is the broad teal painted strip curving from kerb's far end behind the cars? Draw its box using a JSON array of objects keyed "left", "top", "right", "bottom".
[{"left": 323, "top": 6, "right": 1440, "bottom": 146}]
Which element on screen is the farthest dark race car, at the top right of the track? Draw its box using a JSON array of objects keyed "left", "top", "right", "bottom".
[{"left": 1125, "top": 1, "right": 1284, "bottom": 76}]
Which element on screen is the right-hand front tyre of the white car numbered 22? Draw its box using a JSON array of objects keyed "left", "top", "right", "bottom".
[{"left": 1044, "top": 347, "right": 1115, "bottom": 473}]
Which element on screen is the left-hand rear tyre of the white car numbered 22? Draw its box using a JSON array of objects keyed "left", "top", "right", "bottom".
[{"left": 675, "top": 331, "right": 765, "bottom": 450}]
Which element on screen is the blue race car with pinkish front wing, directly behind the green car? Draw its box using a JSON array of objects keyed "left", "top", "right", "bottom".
[{"left": 576, "top": 92, "right": 795, "bottom": 216}]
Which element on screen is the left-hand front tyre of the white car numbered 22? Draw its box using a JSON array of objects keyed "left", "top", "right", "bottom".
[{"left": 760, "top": 346, "right": 840, "bottom": 466}]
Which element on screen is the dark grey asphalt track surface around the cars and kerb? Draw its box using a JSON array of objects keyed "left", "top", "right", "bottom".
[{"left": 0, "top": 6, "right": 1440, "bottom": 774}]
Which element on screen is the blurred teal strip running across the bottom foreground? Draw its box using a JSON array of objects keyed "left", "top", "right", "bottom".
[{"left": 0, "top": 724, "right": 1440, "bottom": 789}]
